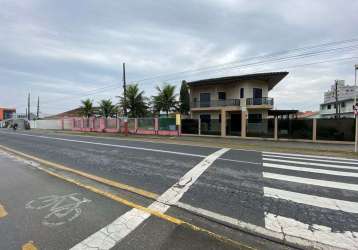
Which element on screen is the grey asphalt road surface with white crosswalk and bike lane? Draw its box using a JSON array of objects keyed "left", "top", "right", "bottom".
[{"left": 0, "top": 130, "right": 358, "bottom": 249}]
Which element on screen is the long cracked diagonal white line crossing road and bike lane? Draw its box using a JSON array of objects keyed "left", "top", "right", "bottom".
[{"left": 71, "top": 148, "right": 229, "bottom": 250}]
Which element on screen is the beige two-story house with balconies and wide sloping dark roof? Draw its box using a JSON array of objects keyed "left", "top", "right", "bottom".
[{"left": 187, "top": 72, "right": 288, "bottom": 135}]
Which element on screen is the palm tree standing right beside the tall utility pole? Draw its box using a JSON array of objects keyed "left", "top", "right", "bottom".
[{"left": 119, "top": 84, "right": 148, "bottom": 118}]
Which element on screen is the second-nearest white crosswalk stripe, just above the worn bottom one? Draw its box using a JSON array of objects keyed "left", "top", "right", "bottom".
[{"left": 264, "top": 187, "right": 358, "bottom": 213}]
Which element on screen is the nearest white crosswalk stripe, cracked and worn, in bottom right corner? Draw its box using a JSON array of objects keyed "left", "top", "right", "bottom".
[{"left": 265, "top": 213, "right": 358, "bottom": 250}]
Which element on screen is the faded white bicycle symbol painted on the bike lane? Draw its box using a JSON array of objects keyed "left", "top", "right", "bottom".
[{"left": 25, "top": 193, "right": 91, "bottom": 227}]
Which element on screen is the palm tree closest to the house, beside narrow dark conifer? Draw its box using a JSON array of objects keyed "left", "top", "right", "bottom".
[{"left": 153, "top": 83, "right": 178, "bottom": 116}]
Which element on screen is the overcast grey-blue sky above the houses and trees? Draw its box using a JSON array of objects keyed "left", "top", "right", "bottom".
[{"left": 0, "top": 0, "right": 358, "bottom": 114}]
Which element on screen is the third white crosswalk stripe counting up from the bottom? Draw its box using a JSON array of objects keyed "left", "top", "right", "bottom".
[{"left": 263, "top": 172, "right": 358, "bottom": 191}]
